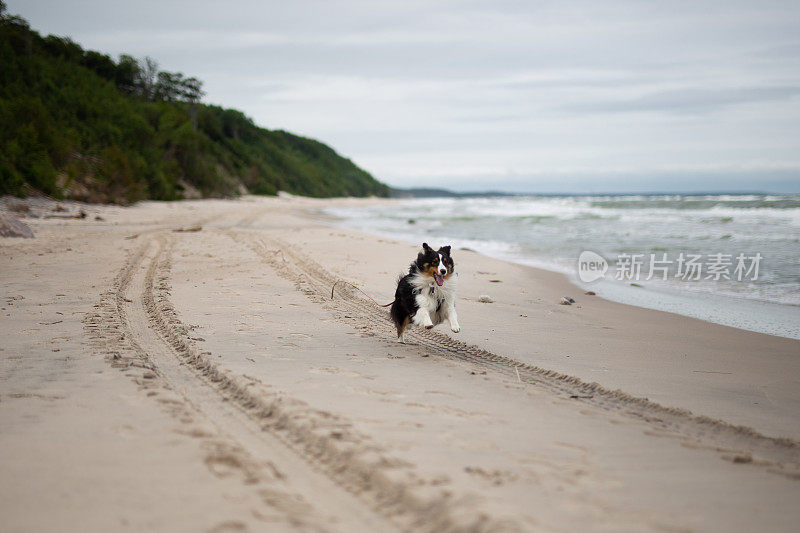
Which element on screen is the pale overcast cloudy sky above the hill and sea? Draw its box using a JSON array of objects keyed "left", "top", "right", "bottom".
[{"left": 6, "top": 0, "right": 800, "bottom": 193}]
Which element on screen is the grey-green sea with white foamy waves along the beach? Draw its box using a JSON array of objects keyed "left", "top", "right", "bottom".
[{"left": 324, "top": 194, "right": 800, "bottom": 338}]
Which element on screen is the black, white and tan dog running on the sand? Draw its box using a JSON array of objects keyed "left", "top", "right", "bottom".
[{"left": 390, "top": 242, "right": 461, "bottom": 343}]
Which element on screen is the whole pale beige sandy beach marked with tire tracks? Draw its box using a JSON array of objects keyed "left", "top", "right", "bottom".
[{"left": 0, "top": 197, "right": 800, "bottom": 531}]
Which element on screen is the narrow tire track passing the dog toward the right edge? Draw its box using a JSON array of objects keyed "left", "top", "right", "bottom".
[{"left": 230, "top": 231, "right": 800, "bottom": 480}]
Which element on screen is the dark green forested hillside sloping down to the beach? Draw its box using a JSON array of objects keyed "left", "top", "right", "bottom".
[{"left": 0, "top": 1, "right": 389, "bottom": 204}]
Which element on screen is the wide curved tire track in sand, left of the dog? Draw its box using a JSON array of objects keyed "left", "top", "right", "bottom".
[{"left": 86, "top": 235, "right": 506, "bottom": 531}]
